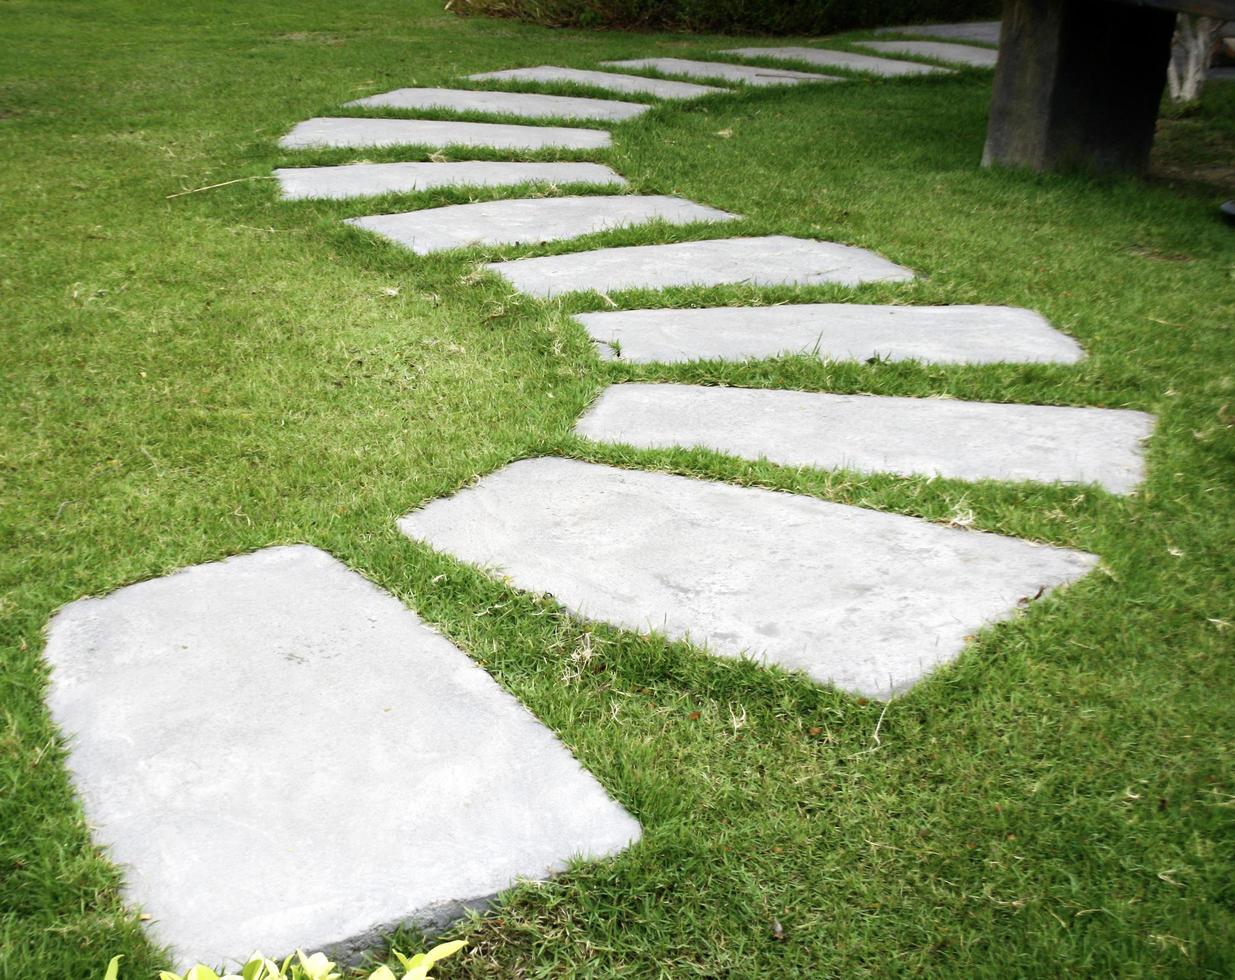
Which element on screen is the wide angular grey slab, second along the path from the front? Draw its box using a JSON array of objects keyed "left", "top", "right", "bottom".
[{"left": 399, "top": 458, "right": 1097, "bottom": 697}]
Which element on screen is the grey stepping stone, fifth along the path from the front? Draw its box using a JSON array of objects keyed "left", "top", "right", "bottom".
[{"left": 484, "top": 235, "right": 914, "bottom": 297}]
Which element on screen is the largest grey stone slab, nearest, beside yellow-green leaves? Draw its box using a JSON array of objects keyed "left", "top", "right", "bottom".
[{"left": 47, "top": 547, "right": 640, "bottom": 963}]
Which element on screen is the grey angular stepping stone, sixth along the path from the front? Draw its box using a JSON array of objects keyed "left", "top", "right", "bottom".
[{"left": 347, "top": 194, "right": 736, "bottom": 255}]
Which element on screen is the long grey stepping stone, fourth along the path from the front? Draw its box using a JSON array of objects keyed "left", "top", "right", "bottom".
[{"left": 576, "top": 302, "right": 1084, "bottom": 364}]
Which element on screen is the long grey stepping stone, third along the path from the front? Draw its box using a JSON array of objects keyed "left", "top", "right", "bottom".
[{"left": 574, "top": 384, "right": 1153, "bottom": 494}]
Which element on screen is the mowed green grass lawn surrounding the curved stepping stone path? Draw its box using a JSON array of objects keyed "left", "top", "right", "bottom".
[{"left": 0, "top": 0, "right": 1235, "bottom": 980}]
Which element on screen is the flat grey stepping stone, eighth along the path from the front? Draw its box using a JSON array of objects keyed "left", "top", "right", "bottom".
[{"left": 279, "top": 116, "right": 610, "bottom": 149}]
